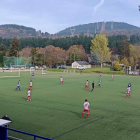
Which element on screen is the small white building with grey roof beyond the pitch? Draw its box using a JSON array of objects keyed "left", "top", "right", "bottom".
[{"left": 72, "top": 61, "right": 91, "bottom": 68}]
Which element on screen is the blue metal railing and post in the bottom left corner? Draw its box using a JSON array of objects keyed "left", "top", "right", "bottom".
[{"left": 0, "top": 126, "right": 53, "bottom": 140}]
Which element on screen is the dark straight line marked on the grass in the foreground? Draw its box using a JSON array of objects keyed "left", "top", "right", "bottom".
[{"left": 52, "top": 117, "right": 104, "bottom": 139}]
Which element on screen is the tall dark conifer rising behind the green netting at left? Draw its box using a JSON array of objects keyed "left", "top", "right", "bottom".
[{"left": 9, "top": 37, "right": 20, "bottom": 57}]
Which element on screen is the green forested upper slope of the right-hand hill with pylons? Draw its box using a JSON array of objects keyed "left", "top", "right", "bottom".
[{"left": 58, "top": 22, "right": 140, "bottom": 36}]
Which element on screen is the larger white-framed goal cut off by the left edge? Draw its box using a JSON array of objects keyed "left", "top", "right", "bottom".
[{"left": 0, "top": 68, "right": 20, "bottom": 78}]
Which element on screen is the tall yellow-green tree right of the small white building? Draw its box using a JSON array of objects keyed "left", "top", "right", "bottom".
[{"left": 90, "top": 34, "right": 111, "bottom": 67}]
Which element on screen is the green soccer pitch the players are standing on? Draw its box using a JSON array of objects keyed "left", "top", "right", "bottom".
[{"left": 0, "top": 72, "right": 140, "bottom": 140}]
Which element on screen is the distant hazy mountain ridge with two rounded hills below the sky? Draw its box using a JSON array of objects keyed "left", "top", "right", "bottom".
[{"left": 0, "top": 22, "right": 140, "bottom": 38}]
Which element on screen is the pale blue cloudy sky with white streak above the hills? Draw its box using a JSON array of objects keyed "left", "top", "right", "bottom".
[{"left": 0, "top": 0, "right": 140, "bottom": 33}]
